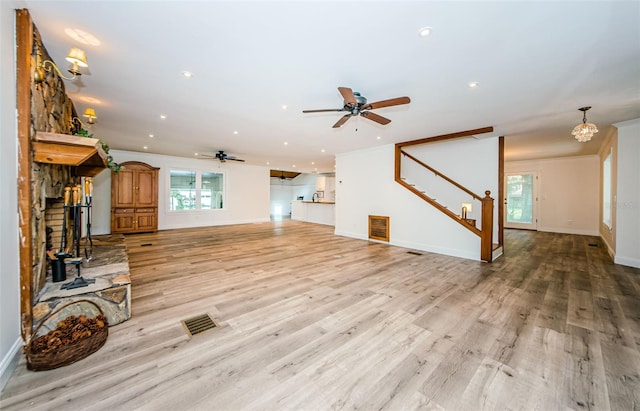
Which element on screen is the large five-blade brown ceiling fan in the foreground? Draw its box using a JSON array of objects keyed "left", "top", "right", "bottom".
[{"left": 302, "top": 87, "right": 411, "bottom": 128}]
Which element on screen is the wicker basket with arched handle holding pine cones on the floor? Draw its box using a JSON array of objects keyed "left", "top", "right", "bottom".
[{"left": 24, "top": 300, "right": 109, "bottom": 371}]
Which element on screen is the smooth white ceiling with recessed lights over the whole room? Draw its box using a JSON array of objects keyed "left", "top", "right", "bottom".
[{"left": 24, "top": 0, "right": 640, "bottom": 172}]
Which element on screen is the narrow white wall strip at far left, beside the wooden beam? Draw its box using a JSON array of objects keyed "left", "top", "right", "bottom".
[{"left": 0, "top": 1, "right": 22, "bottom": 391}]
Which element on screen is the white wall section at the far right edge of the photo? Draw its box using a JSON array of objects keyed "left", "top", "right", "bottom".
[{"left": 614, "top": 119, "right": 640, "bottom": 268}]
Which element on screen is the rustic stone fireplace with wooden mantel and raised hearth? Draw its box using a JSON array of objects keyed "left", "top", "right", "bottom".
[{"left": 18, "top": 17, "right": 131, "bottom": 337}]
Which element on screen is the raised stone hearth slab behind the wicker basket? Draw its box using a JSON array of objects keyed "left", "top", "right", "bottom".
[{"left": 33, "top": 235, "right": 131, "bottom": 334}]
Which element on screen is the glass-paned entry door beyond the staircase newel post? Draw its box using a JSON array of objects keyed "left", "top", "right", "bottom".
[{"left": 504, "top": 172, "right": 538, "bottom": 230}]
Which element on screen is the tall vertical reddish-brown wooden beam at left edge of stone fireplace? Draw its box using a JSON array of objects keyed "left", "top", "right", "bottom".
[{"left": 16, "top": 9, "right": 33, "bottom": 341}]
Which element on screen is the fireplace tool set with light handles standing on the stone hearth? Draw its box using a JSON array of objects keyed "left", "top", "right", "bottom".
[{"left": 51, "top": 177, "right": 95, "bottom": 290}]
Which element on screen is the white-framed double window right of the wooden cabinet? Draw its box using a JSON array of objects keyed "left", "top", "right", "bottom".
[{"left": 169, "top": 170, "right": 224, "bottom": 211}]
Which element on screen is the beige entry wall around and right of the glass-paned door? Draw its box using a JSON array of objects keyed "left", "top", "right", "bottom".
[{"left": 505, "top": 156, "right": 600, "bottom": 236}]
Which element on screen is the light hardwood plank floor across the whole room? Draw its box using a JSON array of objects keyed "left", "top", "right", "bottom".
[{"left": 0, "top": 220, "right": 640, "bottom": 410}]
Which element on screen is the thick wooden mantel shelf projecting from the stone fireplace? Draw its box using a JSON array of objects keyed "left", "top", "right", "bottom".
[{"left": 32, "top": 131, "right": 107, "bottom": 177}]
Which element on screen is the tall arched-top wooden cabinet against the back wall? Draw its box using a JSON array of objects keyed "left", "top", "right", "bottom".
[{"left": 111, "top": 161, "right": 159, "bottom": 233}]
